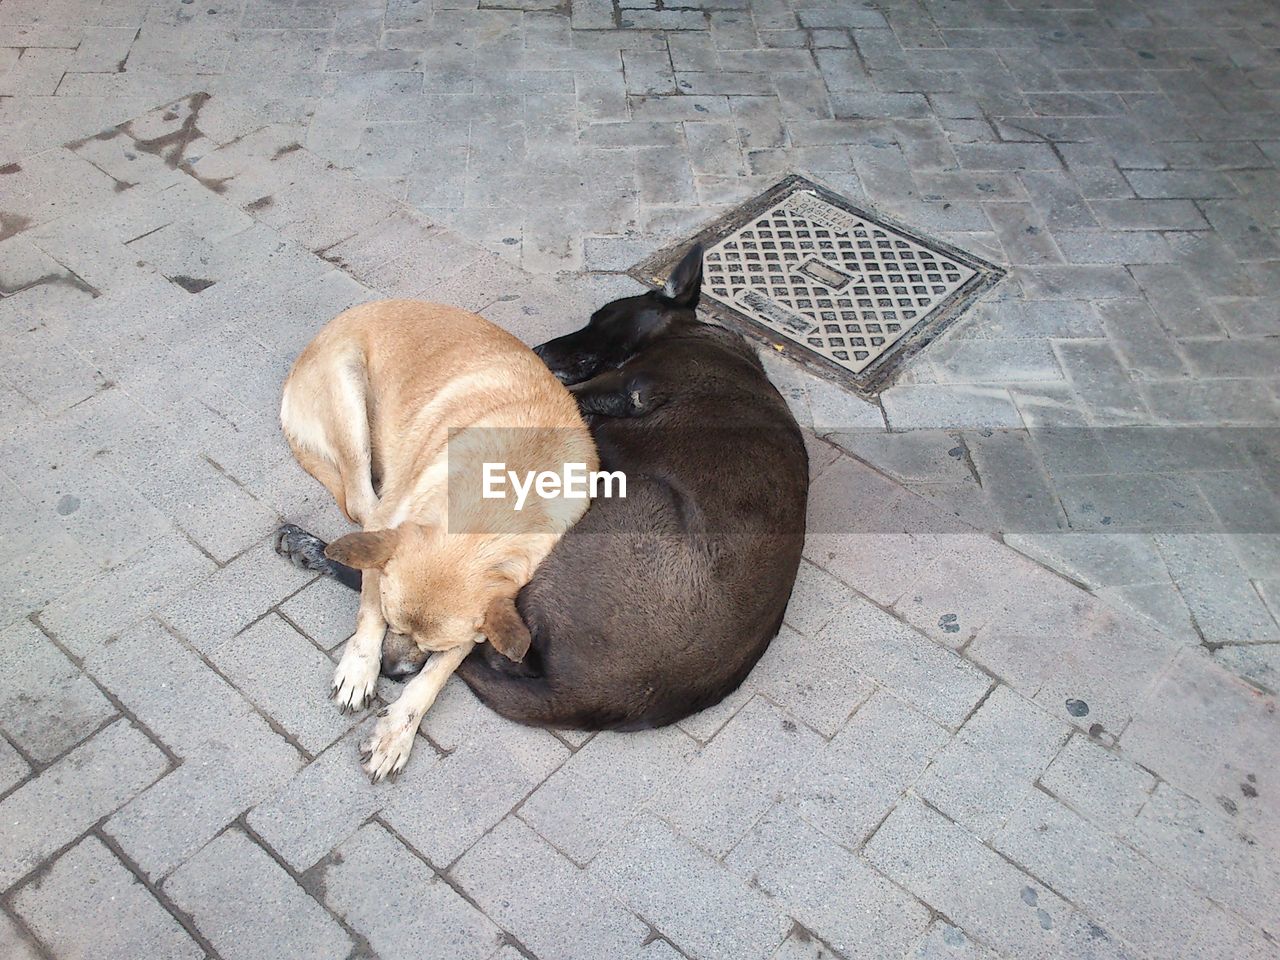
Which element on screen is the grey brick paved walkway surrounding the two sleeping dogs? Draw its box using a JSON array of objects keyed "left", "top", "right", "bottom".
[{"left": 0, "top": 0, "right": 1280, "bottom": 960}]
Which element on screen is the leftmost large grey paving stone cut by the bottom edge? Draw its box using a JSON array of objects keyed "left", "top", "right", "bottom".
[{"left": 14, "top": 836, "right": 205, "bottom": 960}]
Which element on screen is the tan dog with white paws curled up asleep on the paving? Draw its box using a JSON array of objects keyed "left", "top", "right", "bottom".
[{"left": 280, "top": 300, "right": 598, "bottom": 781}]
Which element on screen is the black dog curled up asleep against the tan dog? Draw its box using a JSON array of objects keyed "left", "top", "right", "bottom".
[{"left": 278, "top": 247, "right": 809, "bottom": 730}]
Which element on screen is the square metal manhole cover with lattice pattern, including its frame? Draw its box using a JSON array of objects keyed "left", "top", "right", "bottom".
[{"left": 632, "top": 177, "right": 1004, "bottom": 393}]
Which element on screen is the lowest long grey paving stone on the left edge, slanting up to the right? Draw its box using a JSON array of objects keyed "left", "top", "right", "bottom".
[{"left": 0, "top": 719, "right": 169, "bottom": 888}]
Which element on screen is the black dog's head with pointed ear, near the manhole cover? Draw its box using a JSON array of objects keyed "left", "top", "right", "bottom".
[{"left": 534, "top": 243, "right": 703, "bottom": 384}]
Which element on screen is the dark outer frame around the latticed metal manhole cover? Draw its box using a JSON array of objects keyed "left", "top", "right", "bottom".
[{"left": 627, "top": 174, "right": 1006, "bottom": 398}]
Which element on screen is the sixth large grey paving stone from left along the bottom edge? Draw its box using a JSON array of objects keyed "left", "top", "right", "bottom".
[{"left": 724, "top": 808, "right": 929, "bottom": 956}]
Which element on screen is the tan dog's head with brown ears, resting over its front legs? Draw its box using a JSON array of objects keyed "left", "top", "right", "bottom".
[{"left": 325, "top": 524, "right": 530, "bottom": 660}]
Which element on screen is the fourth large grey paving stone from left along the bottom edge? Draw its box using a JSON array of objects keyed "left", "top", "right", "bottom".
[{"left": 451, "top": 817, "right": 649, "bottom": 960}]
